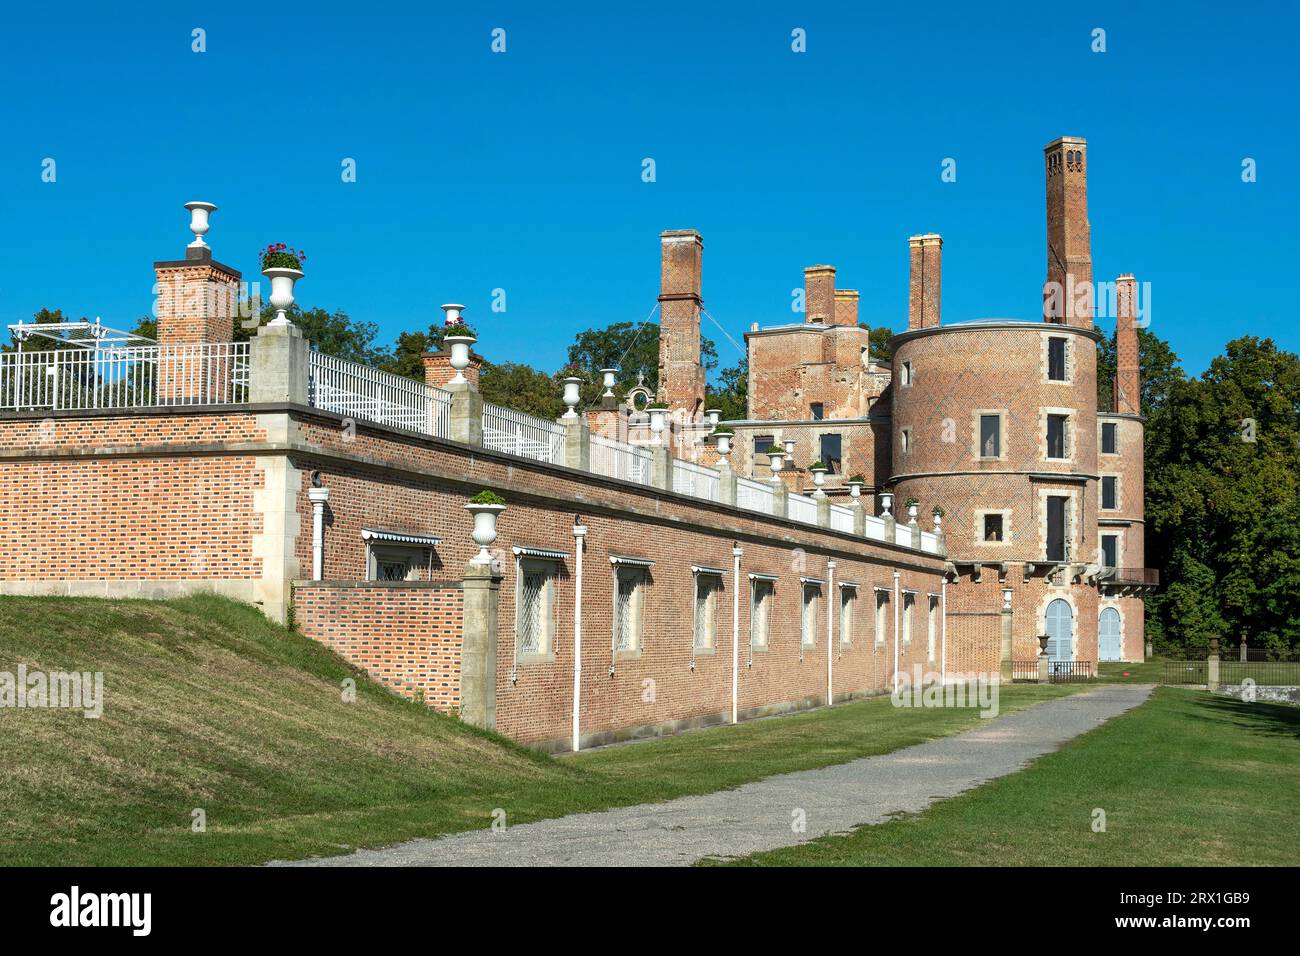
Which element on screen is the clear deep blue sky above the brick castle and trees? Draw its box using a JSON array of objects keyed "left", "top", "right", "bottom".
[{"left": 0, "top": 3, "right": 1300, "bottom": 373}]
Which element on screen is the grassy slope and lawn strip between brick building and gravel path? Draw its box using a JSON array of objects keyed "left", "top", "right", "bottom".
[{"left": 0, "top": 596, "right": 1082, "bottom": 865}]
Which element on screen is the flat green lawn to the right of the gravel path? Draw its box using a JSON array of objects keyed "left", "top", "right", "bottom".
[{"left": 712, "top": 688, "right": 1300, "bottom": 866}]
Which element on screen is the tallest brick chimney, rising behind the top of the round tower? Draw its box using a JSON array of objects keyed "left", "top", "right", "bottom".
[{"left": 1043, "top": 137, "right": 1092, "bottom": 329}]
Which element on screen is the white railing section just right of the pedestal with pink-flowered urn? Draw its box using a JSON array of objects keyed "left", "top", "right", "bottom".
[{"left": 307, "top": 351, "right": 451, "bottom": 437}]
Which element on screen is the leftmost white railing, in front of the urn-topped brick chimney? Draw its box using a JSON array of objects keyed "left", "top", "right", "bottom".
[{"left": 0, "top": 342, "right": 248, "bottom": 410}]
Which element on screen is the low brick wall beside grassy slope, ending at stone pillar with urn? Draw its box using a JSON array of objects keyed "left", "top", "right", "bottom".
[{"left": 294, "top": 581, "right": 463, "bottom": 710}]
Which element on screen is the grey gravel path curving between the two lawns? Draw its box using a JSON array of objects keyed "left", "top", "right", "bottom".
[{"left": 271, "top": 684, "right": 1152, "bottom": 866}]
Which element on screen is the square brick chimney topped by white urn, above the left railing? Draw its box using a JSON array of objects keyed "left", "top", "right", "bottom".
[{"left": 153, "top": 203, "right": 241, "bottom": 345}]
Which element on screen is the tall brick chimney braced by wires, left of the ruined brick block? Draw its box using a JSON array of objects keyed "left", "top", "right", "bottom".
[{"left": 655, "top": 229, "right": 705, "bottom": 418}]
